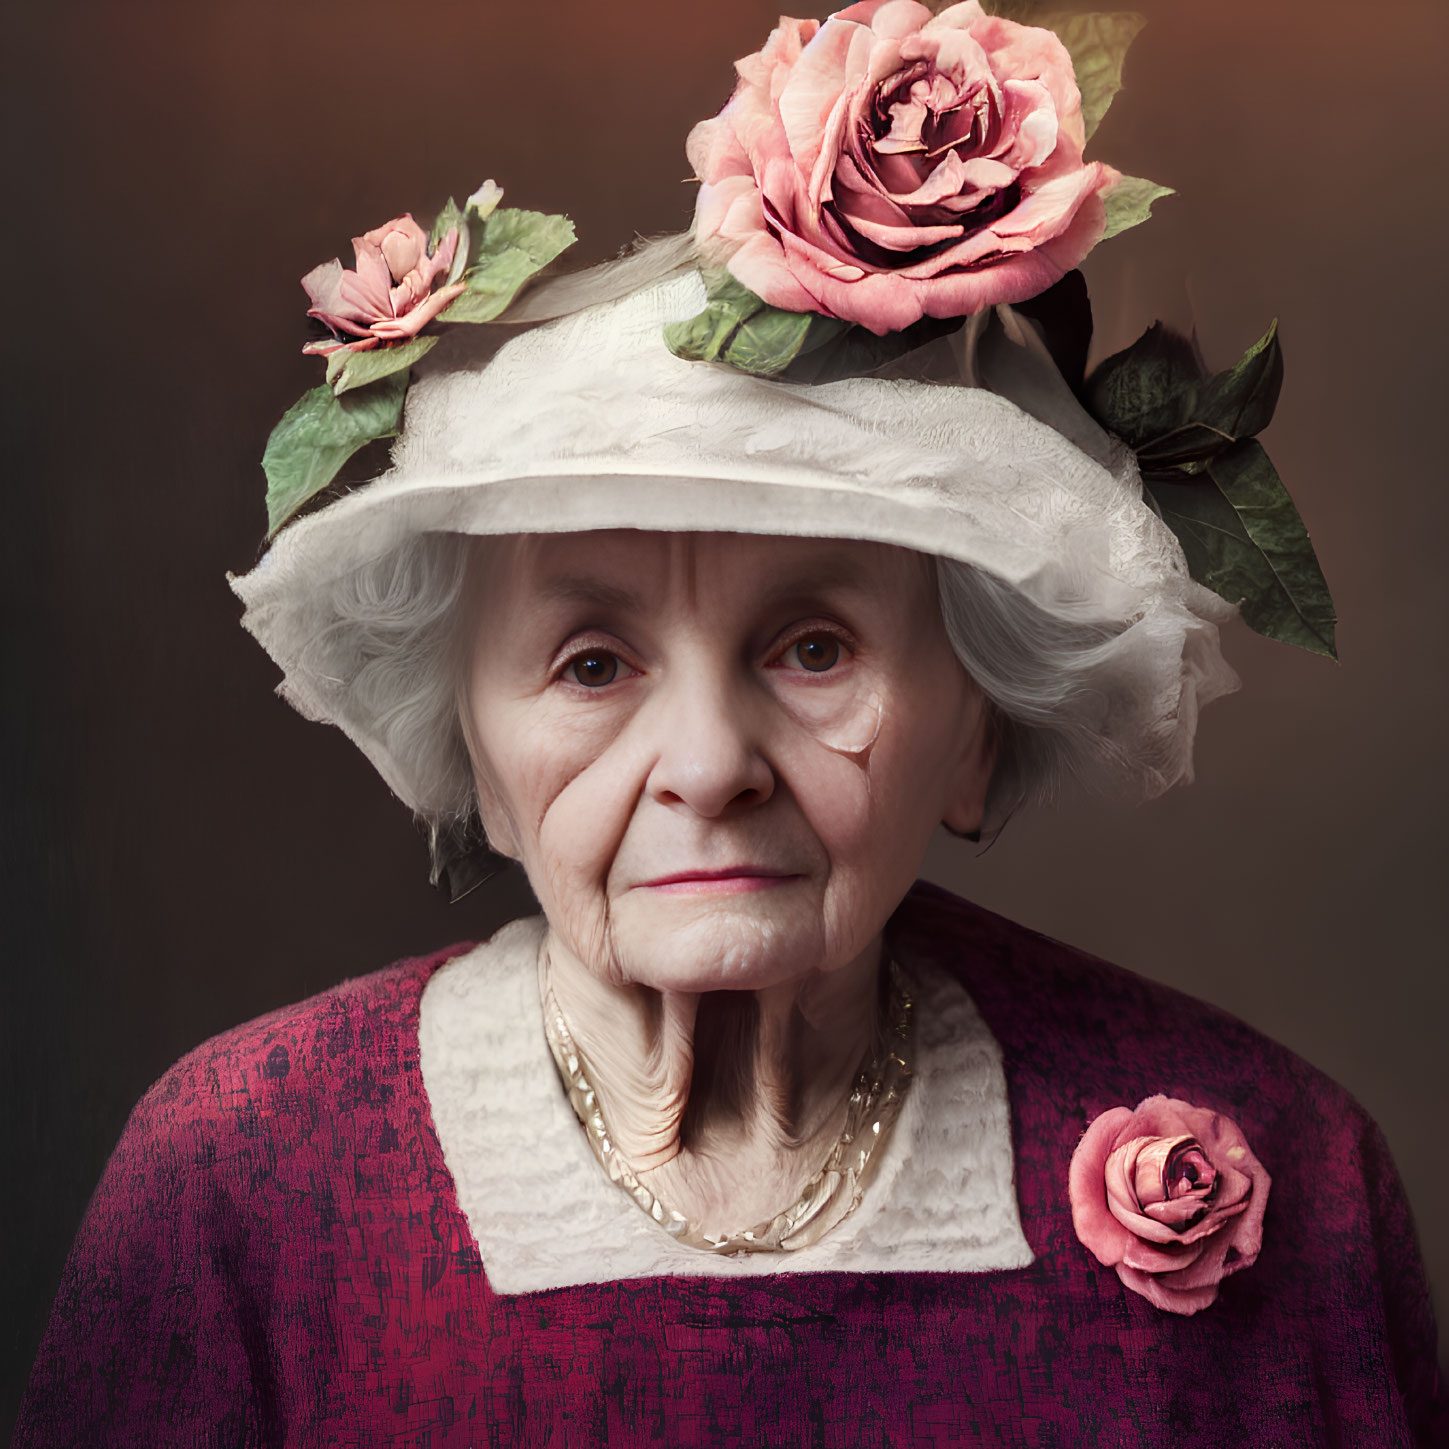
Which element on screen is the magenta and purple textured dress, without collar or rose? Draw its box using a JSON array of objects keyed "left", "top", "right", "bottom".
[{"left": 14, "top": 885, "right": 1449, "bottom": 1449}]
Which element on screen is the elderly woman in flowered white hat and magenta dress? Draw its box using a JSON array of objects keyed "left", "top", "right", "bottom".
[{"left": 19, "top": 0, "right": 1449, "bottom": 1446}]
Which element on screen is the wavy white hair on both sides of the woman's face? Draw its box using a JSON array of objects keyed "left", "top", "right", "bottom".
[{"left": 312, "top": 533, "right": 1130, "bottom": 878}]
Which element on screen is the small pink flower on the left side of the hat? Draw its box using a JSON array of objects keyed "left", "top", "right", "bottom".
[{"left": 301, "top": 214, "right": 464, "bottom": 356}]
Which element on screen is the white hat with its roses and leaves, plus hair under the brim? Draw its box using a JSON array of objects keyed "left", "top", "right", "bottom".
[{"left": 235, "top": 0, "right": 1333, "bottom": 846}]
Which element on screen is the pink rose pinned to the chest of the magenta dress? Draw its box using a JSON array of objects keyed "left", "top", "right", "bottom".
[{"left": 1068, "top": 1097, "right": 1272, "bottom": 1313}]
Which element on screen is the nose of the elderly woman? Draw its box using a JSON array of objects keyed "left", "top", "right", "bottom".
[{"left": 646, "top": 671, "right": 775, "bottom": 819}]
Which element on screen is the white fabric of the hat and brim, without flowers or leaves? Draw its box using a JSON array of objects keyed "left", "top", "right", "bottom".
[{"left": 233, "top": 255, "right": 1236, "bottom": 816}]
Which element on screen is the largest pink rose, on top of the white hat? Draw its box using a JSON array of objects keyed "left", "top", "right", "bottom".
[{"left": 688, "top": 0, "right": 1119, "bottom": 333}]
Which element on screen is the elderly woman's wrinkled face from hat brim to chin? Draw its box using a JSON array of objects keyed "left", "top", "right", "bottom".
[{"left": 462, "top": 532, "right": 991, "bottom": 991}]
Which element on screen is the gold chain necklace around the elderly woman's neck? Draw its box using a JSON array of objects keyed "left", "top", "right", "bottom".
[{"left": 543, "top": 961, "right": 911, "bottom": 1253}]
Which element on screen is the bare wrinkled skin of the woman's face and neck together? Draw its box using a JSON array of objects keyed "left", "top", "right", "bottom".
[{"left": 461, "top": 532, "right": 991, "bottom": 1227}]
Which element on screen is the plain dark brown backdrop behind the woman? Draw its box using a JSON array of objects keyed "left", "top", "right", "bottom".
[{"left": 0, "top": 0, "right": 1449, "bottom": 1420}]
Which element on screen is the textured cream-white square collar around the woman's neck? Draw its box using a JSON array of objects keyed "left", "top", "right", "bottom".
[{"left": 419, "top": 917, "right": 1032, "bottom": 1294}]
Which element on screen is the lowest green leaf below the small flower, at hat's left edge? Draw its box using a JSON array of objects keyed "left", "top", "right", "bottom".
[{"left": 262, "top": 370, "right": 407, "bottom": 538}]
